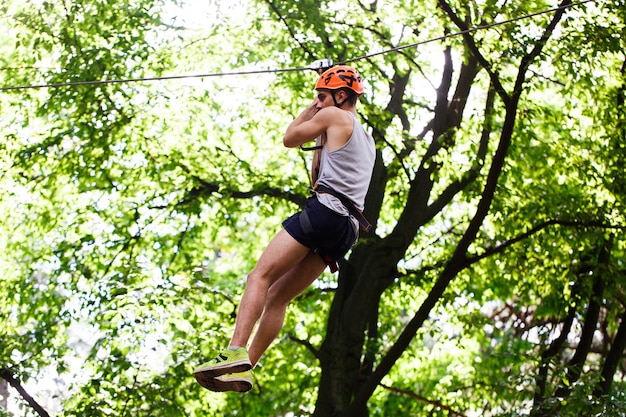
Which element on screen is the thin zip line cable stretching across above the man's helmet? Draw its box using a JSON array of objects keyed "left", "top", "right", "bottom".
[{"left": 0, "top": 0, "right": 596, "bottom": 92}]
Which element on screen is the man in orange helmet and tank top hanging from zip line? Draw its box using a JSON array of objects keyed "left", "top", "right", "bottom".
[{"left": 194, "top": 66, "right": 375, "bottom": 392}]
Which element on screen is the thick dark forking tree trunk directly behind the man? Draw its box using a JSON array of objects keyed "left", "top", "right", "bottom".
[{"left": 314, "top": 37, "right": 482, "bottom": 416}]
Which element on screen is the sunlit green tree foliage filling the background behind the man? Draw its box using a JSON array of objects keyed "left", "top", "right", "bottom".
[{"left": 0, "top": 0, "right": 626, "bottom": 416}]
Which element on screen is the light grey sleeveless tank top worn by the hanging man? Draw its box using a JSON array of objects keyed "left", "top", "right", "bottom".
[{"left": 317, "top": 114, "right": 376, "bottom": 216}]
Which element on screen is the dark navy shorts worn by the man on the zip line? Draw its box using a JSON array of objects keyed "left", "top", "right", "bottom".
[{"left": 283, "top": 197, "right": 356, "bottom": 263}]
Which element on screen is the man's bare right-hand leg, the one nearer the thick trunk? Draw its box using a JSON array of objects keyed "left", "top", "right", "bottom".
[{"left": 249, "top": 252, "right": 326, "bottom": 367}]
